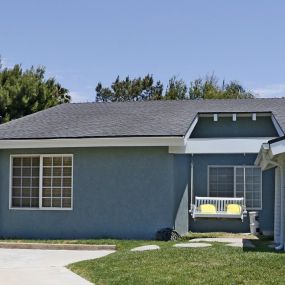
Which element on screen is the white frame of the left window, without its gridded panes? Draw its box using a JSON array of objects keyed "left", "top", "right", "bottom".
[{"left": 9, "top": 153, "right": 73, "bottom": 211}]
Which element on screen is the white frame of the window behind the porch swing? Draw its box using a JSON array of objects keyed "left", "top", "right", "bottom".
[{"left": 207, "top": 165, "right": 263, "bottom": 211}]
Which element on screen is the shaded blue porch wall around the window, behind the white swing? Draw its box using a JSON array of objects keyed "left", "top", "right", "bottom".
[{"left": 189, "top": 154, "right": 274, "bottom": 232}]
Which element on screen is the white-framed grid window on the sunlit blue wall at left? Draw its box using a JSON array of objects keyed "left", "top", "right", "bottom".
[{"left": 10, "top": 154, "right": 73, "bottom": 210}]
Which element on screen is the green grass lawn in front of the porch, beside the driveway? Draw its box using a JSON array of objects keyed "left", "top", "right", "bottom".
[{"left": 68, "top": 235, "right": 285, "bottom": 285}]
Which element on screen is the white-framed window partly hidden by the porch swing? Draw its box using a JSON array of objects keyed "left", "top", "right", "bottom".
[{"left": 208, "top": 165, "right": 262, "bottom": 210}]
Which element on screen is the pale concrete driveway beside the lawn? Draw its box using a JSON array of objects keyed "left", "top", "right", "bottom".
[{"left": 0, "top": 246, "right": 114, "bottom": 285}]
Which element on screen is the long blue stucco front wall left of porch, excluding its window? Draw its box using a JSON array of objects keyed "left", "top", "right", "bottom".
[{"left": 0, "top": 147, "right": 188, "bottom": 239}]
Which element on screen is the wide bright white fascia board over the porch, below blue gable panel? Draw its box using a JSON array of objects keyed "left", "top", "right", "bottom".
[{"left": 169, "top": 137, "right": 272, "bottom": 154}]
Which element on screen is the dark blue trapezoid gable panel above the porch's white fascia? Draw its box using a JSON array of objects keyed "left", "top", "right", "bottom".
[{"left": 191, "top": 117, "right": 278, "bottom": 138}]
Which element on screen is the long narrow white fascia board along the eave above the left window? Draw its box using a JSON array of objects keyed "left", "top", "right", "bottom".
[{"left": 0, "top": 137, "right": 184, "bottom": 149}]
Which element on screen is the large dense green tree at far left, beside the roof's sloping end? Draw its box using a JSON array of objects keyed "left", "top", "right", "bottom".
[{"left": 0, "top": 61, "right": 71, "bottom": 122}]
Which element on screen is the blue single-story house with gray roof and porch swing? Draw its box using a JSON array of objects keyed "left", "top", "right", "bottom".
[{"left": 0, "top": 99, "right": 285, "bottom": 248}]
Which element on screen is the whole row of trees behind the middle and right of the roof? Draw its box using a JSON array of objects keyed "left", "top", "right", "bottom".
[{"left": 95, "top": 74, "right": 255, "bottom": 102}]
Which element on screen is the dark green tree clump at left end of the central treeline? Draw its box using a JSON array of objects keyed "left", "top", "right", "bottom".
[{"left": 95, "top": 74, "right": 163, "bottom": 102}]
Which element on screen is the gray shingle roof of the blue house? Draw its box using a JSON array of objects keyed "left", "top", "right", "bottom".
[{"left": 0, "top": 99, "right": 285, "bottom": 139}]
